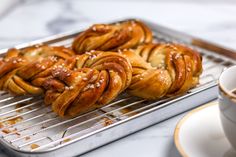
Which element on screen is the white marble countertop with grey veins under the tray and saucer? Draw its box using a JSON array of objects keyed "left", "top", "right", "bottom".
[{"left": 0, "top": 0, "right": 236, "bottom": 157}]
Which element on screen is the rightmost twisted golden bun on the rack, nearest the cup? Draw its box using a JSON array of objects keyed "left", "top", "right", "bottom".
[{"left": 122, "top": 44, "right": 202, "bottom": 99}]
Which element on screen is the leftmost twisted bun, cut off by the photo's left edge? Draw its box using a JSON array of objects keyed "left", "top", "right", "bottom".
[{"left": 0, "top": 45, "right": 74, "bottom": 95}]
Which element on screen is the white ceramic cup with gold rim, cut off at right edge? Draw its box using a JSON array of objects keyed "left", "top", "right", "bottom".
[{"left": 219, "top": 66, "right": 236, "bottom": 149}]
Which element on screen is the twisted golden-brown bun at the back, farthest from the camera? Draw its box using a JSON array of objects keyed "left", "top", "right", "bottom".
[{"left": 72, "top": 20, "right": 152, "bottom": 54}]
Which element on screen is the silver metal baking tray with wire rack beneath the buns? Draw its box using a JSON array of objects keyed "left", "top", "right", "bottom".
[{"left": 0, "top": 20, "right": 236, "bottom": 157}]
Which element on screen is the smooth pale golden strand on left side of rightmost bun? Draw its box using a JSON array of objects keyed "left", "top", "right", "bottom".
[{"left": 122, "top": 51, "right": 172, "bottom": 99}]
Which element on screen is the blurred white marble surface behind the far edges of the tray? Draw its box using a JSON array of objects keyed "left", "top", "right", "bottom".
[{"left": 0, "top": 0, "right": 236, "bottom": 48}]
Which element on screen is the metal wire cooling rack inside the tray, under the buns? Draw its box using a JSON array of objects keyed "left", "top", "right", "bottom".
[{"left": 0, "top": 19, "right": 235, "bottom": 156}]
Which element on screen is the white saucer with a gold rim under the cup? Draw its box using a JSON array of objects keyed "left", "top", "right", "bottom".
[{"left": 174, "top": 102, "right": 236, "bottom": 157}]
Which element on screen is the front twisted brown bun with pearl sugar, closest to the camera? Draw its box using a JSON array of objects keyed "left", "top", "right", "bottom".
[{"left": 43, "top": 51, "right": 132, "bottom": 117}]
